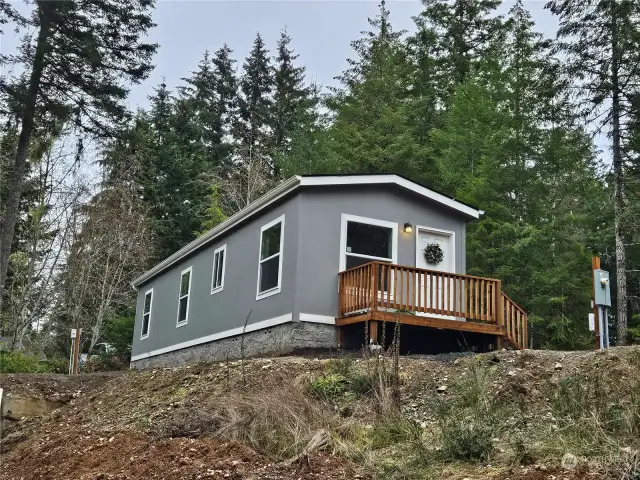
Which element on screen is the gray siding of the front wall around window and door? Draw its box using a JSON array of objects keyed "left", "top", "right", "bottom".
[{"left": 295, "top": 186, "right": 466, "bottom": 317}]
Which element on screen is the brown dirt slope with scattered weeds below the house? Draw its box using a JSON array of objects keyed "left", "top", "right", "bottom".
[{"left": 0, "top": 347, "right": 640, "bottom": 480}]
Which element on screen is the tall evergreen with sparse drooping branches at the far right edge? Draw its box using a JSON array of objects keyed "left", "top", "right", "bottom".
[{"left": 547, "top": 0, "right": 640, "bottom": 344}]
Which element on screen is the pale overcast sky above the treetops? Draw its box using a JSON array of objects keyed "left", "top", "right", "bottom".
[{"left": 129, "top": 0, "right": 557, "bottom": 108}]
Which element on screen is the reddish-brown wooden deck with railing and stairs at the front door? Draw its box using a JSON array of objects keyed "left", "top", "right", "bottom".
[{"left": 336, "top": 262, "right": 528, "bottom": 349}]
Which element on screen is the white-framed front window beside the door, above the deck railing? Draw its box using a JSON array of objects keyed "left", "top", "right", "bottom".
[{"left": 339, "top": 213, "right": 398, "bottom": 272}]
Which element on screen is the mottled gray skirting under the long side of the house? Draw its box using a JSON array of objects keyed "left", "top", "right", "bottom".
[{"left": 131, "top": 320, "right": 338, "bottom": 369}]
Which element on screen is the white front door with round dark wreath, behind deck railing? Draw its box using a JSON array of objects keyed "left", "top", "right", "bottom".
[{"left": 416, "top": 227, "right": 455, "bottom": 319}]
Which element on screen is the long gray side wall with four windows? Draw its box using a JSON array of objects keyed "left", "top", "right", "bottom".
[{"left": 132, "top": 195, "right": 301, "bottom": 356}]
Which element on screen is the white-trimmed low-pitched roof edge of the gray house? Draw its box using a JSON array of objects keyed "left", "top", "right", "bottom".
[{"left": 131, "top": 174, "right": 484, "bottom": 288}]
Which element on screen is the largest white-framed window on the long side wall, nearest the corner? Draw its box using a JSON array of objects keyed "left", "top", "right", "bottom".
[{"left": 256, "top": 215, "right": 284, "bottom": 300}]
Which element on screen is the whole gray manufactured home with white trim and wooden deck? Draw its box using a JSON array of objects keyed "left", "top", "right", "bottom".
[{"left": 131, "top": 175, "right": 526, "bottom": 368}]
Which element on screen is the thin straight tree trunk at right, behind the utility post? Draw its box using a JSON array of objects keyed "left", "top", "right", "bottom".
[{"left": 611, "top": 2, "right": 627, "bottom": 345}]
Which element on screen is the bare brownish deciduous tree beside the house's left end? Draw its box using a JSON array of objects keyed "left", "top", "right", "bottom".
[{"left": 59, "top": 168, "right": 152, "bottom": 349}]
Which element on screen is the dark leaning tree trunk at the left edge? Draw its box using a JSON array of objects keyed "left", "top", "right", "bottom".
[{"left": 0, "top": 1, "right": 54, "bottom": 312}]
